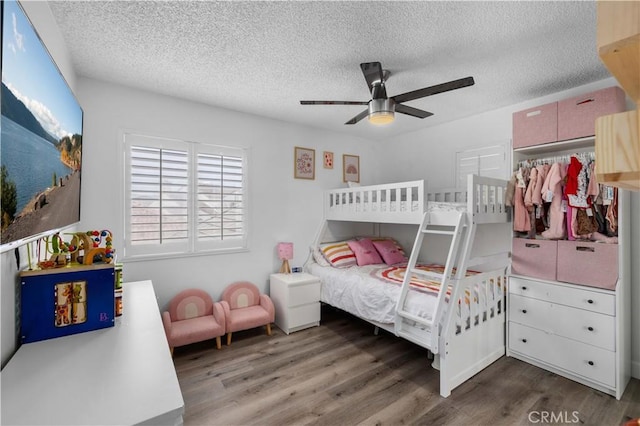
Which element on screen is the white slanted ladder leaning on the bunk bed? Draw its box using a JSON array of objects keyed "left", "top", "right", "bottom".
[{"left": 395, "top": 212, "right": 469, "bottom": 354}]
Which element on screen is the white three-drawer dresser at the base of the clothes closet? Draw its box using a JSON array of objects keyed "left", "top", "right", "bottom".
[{"left": 508, "top": 277, "right": 626, "bottom": 395}]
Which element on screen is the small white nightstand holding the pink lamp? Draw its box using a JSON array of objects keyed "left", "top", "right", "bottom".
[{"left": 270, "top": 273, "right": 320, "bottom": 334}]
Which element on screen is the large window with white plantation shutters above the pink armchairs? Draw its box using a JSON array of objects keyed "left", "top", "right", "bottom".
[{"left": 124, "top": 133, "right": 247, "bottom": 258}]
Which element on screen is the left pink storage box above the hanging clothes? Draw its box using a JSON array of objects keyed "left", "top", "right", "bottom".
[{"left": 513, "top": 102, "right": 558, "bottom": 149}]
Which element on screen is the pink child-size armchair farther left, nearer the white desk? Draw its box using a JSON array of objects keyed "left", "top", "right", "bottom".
[{"left": 162, "top": 289, "right": 226, "bottom": 355}]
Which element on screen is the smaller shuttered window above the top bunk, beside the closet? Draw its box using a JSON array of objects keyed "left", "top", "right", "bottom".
[{"left": 456, "top": 144, "right": 510, "bottom": 188}]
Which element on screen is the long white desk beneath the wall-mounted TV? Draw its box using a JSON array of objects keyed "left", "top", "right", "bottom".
[{"left": 0, "top": 281, "right": 184, "bottom": 425}]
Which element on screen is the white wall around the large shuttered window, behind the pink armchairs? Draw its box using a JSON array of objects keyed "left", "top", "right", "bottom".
[{"left": 79, "top": 78, "right": 378, "bottom": 316}]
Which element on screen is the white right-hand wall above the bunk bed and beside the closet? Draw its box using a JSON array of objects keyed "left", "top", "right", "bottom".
[{"left": 380, "top": 78, "right": 640, "bottom": 378}]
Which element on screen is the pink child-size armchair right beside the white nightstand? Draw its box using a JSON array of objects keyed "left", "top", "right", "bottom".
[{"left": 220, "top": 281, "right": 275, "bottom": 346}]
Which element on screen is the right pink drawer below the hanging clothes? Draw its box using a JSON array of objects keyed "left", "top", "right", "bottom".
[{"left": 556, "top": 241, "right": 618, "bottom": 290}]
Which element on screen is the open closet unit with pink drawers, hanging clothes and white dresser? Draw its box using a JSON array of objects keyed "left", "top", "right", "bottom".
[{"left": 507, "top": 87, "right": 631, "bottom": 399}]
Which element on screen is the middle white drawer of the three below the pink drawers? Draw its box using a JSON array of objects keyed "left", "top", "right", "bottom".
[{"left": 508, "top": 294, "right": 616, "bottom": 351}]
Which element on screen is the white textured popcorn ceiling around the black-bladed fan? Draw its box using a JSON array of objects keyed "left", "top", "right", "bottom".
[{"left": 49, "top": 1, "right": 609, "bottom": 139}]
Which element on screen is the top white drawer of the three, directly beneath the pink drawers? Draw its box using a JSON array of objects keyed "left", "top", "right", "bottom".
[{"left": 509, "top": 277, "right": 616, "bottom": 315}]
